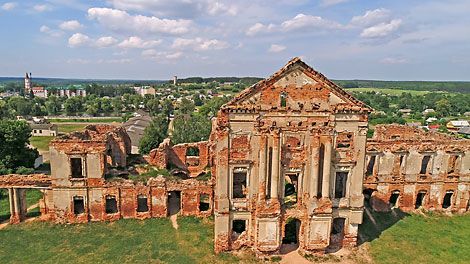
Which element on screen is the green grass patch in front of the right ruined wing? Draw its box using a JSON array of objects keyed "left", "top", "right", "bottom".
[{"left": 370, "top": 215, "right": 470, "bottom": 263}]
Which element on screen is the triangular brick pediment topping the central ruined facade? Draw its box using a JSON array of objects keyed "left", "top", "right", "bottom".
[{"left": 226, "top": 58, "right": 372, "bottom": 111}]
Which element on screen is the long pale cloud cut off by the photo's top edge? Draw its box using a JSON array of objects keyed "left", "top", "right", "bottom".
[{"left": 109, "top": 0, "right": 239, "bottom": 18}]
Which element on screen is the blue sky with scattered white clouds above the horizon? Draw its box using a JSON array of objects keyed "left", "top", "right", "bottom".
[{"left": 0, "top": 0, "right": 470, "bottom": 80}]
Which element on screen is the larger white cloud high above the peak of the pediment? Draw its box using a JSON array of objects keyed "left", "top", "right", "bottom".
[{"left": 281, "top": 14, "right": 344, "bottom": 31}]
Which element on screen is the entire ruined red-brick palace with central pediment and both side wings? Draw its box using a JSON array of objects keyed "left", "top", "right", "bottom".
[{"left": 0, "top": 58, "right": 470, "bottom": 254}]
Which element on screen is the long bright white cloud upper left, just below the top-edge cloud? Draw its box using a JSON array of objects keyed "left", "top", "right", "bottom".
[{"left": 88, "top": 8, "right": 192, "bottom": 34}]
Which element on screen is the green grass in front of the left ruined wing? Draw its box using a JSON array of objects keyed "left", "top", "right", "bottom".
[{"left": 0, "top": 217, "right": 257, "bottom": 263}]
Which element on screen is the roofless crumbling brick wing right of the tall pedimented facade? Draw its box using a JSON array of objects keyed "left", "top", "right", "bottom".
[{"left": 364, "top": 125, "right": 470, "bottom": 212}]
